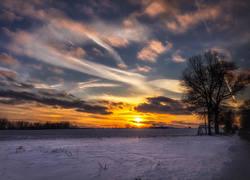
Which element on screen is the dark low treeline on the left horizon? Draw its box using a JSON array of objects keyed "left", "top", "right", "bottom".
[{"left": 0, "top": 118, "right": 78, "bottom": 130}]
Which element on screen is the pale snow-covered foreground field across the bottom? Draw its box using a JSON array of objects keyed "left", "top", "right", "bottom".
[{"left": 0, "top": 131, "right": 250, "bottom": 180}]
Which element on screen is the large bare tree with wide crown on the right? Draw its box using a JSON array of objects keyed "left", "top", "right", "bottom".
[{"left": 181, "top": 50, "right": 246, "bottom": 135}]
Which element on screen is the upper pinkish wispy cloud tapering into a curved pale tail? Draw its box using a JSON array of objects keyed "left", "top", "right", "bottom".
[{"left": 1, "top": 1, "right": 126, "bottom": 68}]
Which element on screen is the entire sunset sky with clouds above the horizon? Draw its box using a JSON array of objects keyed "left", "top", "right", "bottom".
[{"left": 0, "top": 0, "right": 250, "bottom": 128}]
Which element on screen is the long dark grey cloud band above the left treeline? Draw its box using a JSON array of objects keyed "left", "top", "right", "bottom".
[{"left": 0, "top": 90, "right": 112, "bottom": 115}]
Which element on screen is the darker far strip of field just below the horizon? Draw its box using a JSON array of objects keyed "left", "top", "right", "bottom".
[{"left": 0, "top": 128, "right": 197, "bottom": 141}]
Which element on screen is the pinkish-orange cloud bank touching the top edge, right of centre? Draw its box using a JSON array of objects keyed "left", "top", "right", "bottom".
[{"left": 141, "top": 0, "right": 222, "bottom": 33}]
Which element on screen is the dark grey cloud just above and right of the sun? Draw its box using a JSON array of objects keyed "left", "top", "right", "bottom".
[{"left": 135, "top": 96, "right": 190, "bottom": 115}]
